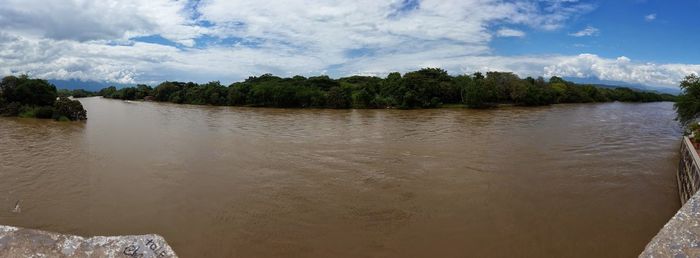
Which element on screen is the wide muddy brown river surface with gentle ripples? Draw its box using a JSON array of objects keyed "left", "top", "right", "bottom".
[{"left": 0, "top": 98, "right": 681, "bottom": 257}]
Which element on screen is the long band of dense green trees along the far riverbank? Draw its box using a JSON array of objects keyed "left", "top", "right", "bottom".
[{"left": 97, "top": 68, "right": 675, "bottom": 109}]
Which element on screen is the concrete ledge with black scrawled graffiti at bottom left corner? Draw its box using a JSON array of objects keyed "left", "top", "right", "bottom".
[{"left": 0, "top": 225, "right": 177, "bottom": 258}]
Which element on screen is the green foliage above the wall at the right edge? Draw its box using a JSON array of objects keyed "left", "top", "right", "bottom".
[{"left": 674, "top": 75, "right": 700, "bottom": 126}]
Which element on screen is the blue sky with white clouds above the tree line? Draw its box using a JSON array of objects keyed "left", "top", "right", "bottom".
[{"left": 0, "top": 0, "right": 700, "bottom": 88}]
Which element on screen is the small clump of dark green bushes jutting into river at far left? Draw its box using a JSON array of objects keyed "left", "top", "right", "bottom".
[{"left": 0, "top": 75, "right": 87, "bottom": 121}]
